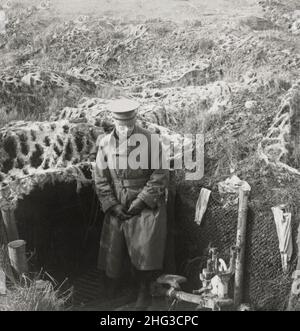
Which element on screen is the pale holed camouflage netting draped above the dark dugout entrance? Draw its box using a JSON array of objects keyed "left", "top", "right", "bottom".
[{"left": 0, "top": 121, "right": 103, "bottom": 209}]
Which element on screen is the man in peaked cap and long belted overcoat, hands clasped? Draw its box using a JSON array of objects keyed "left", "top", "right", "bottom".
[{"left": 95, "top": 99, "right": 169, "bottom": 309}]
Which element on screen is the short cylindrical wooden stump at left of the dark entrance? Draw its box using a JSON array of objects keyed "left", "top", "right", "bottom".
[{"left": 8, "top": 240, "right": 28, "bottom": 275}]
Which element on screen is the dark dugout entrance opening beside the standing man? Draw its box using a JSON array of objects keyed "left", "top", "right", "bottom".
[{"left": 16, "top": 183, "right": 103, "bottom": 282}]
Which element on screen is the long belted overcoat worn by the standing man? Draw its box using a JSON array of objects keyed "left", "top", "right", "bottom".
[{"left": 95, "top": 125, "right": 169, "bottom": 278}]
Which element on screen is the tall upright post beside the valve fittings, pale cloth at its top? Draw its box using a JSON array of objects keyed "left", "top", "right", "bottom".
[{"left": 234, "top": 187, "right": 250, "bottom": 307}]
